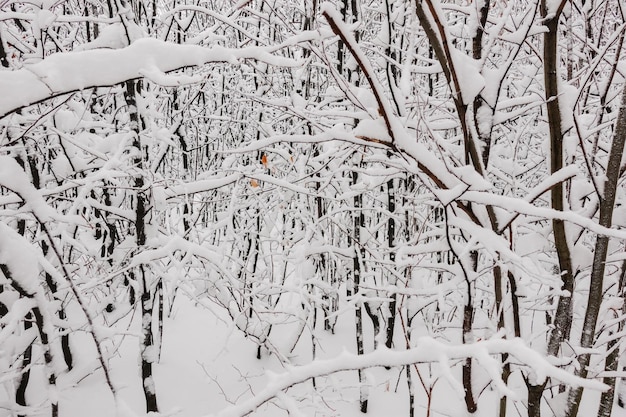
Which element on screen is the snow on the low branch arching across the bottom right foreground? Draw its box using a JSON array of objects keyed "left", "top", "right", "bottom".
[{"left": 214, "top": 337, "right": 607, "bottom": 417}]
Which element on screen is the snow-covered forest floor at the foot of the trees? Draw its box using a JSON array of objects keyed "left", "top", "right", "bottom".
[{"left": 0, "top": 296, "right": 626, "bottom": 417}]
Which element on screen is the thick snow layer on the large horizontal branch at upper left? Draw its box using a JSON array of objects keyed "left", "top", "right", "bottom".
[{"left": 0, "top": 38, "right": 298, "bottom": 118}]
